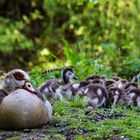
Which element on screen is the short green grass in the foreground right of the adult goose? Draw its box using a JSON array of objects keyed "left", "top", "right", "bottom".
[{"left": 50, "top": 101, "right": 140, "bottom": 139}]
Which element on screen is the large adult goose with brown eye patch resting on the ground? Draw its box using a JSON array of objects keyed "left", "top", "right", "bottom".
[{"left": 0, "top": 69, "right": 52, "bottom": 129}]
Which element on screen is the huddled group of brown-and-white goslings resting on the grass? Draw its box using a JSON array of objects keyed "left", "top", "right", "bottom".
[{"left": 38, "top": 68, "right": 140, "bottom": 107}]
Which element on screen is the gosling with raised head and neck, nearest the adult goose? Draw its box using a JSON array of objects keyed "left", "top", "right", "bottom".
[{"left": 38, "top": 67, "right": 76, "bottom": 100}]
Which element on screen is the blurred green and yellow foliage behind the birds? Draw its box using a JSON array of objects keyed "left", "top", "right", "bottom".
[{"left": 0, "top": 0, "right": 140, "bottom": 78}]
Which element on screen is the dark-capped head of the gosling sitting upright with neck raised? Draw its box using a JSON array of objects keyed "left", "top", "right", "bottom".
[{"left": 62, "top": 67, "right": 77, "bottom": 84}]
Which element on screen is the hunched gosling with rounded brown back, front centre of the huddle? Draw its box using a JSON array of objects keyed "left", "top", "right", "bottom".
[{"left": 73, "top": 80, "right": 108, "bottom": 107}]
